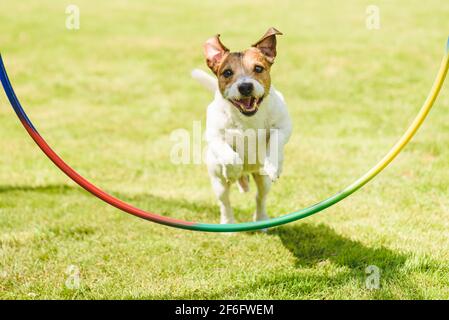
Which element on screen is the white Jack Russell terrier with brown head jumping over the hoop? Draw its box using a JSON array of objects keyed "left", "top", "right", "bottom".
[{"left": 192, "top": 28, "right": 292, "bottom": 224}]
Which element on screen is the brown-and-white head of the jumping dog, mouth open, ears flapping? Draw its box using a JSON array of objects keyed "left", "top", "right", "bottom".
[{"left": 204, "top": 28, "right": 282, "bottom": 116}]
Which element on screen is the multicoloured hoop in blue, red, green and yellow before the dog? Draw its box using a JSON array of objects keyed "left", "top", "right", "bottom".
[{"left": 0, "top": 39, "right": 449, "bottom": 232}]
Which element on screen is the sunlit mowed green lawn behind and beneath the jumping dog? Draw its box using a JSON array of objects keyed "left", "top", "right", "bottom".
[{"left": 0, "top": 0, "right": 449, "bottom": 299}]
